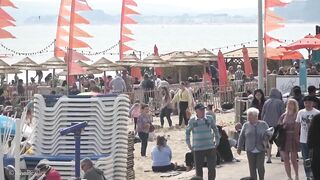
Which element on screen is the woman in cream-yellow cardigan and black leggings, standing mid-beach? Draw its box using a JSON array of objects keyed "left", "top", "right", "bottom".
[{"left": 171, "top": 82, "right": 192, "bottom": 126}]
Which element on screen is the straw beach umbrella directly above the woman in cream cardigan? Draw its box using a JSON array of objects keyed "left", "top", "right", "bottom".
[{"left": 167, "top": 52, "right": 202, "bottom": 81}]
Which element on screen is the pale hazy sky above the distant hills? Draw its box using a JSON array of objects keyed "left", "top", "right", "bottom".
[{"left": 16, "top": 0, "right": 264, "bottom": 15}]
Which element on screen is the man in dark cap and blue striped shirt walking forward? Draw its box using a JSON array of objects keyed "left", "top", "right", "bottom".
[{"left": 186, "top": 104, "right": 220, "bottom": 180}]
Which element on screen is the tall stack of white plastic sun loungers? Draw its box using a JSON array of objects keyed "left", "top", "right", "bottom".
[{"left": 25, "top": 95, "right": 129, "bottom": 180}]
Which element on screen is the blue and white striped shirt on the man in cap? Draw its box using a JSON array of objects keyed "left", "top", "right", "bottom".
[{"left": 186, "top": 115, "right": 220, "bottom": 151}]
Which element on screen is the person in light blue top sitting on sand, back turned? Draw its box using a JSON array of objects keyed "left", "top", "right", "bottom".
[{"left": 151, "top": 136, "right": 175, "bottom": 172}]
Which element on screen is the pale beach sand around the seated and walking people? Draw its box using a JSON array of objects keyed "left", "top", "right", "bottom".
[{"left": 130, "top": 113, "right": 305, "bottom": 180}]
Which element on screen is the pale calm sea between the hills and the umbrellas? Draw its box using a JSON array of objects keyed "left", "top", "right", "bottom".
[{"left": 0, "top": 24, "right": 315, "bottom": 79}]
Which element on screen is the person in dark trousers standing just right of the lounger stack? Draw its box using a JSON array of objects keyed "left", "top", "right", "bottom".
[{"left": 137, "top": 104, "right": 152, "bottom": 156}]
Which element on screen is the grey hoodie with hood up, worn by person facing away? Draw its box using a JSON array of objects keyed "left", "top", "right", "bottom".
[{"left": 261, "top": 88, "right": 285, "bottom": 127}]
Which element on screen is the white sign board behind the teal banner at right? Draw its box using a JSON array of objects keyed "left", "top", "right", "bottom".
[{"left": 276, "top": 75, "right": 320, "bottom": 94}]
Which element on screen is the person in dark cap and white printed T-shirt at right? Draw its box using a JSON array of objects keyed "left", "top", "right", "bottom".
[{"left": 296, "top": 96, "right": 320, "bottom": 180}]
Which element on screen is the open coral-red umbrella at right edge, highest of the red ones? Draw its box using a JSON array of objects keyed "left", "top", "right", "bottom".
[{"left": 285, "top": 34, "right": 320, "bottom": 60}]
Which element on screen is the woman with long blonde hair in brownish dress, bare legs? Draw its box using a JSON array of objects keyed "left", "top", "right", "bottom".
[{"left": 279, "top": 98, "right": 300, "bottom": 180}]
